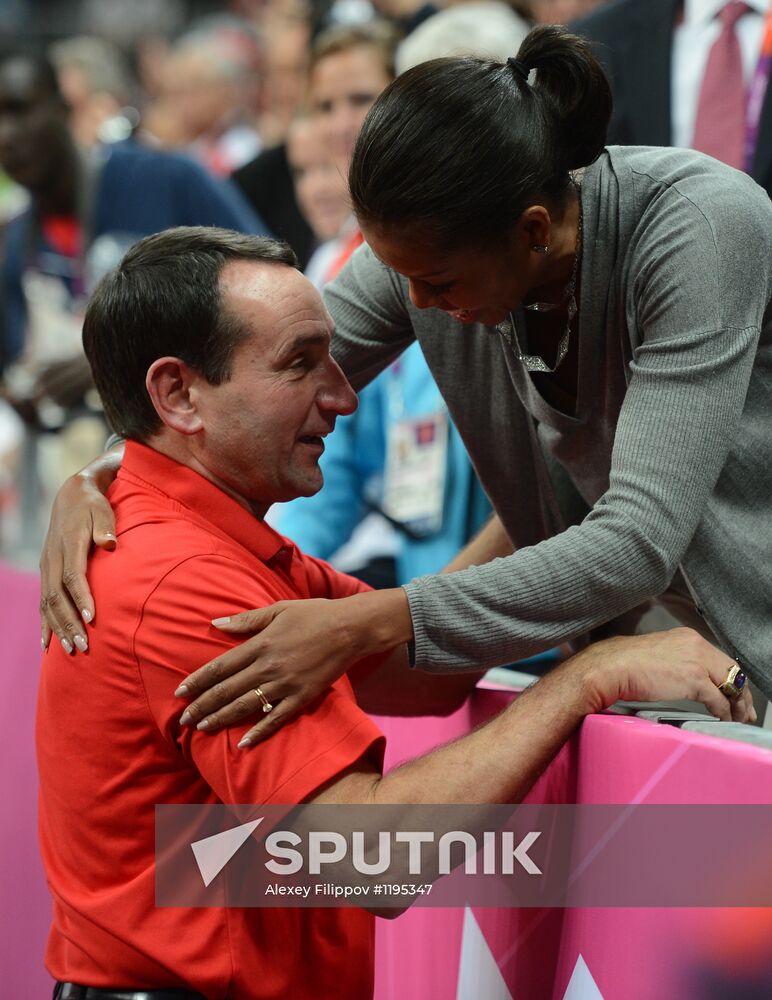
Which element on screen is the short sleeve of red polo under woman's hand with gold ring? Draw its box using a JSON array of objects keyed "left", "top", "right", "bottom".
[{"left": 133, "top": 553, "right": 384, "bottom": 803}]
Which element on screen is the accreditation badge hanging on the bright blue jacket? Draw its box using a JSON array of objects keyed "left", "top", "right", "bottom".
[{"left": 382, "top": 411, "right": 448, "bottom": 535}]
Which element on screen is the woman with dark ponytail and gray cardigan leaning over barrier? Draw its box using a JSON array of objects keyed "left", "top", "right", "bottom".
[{"left": 42, "top": 27, "right": 772, "bottom": 733}]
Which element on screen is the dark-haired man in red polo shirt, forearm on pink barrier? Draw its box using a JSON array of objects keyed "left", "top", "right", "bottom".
[{"left": 37, "top": 229, "right": 740, "bottom": 1000}]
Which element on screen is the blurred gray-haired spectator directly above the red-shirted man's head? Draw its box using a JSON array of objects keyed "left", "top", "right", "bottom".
[{"left": 147, "top": 18, "right": 262, "bottom": 177}]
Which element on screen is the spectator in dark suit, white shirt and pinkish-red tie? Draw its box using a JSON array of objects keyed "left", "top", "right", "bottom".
[{"left": 573, "top": 0, "right": 772, "bottom": 195}]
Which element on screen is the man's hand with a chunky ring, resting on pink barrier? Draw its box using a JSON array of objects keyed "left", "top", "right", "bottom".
[{"left": 580, "top": 628, "right": 756, "bottom": 722}]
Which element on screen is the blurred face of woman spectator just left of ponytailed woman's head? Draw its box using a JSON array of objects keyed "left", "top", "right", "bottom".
[{"left": 309, "top": 45, "right": 391, "bottom": 175}]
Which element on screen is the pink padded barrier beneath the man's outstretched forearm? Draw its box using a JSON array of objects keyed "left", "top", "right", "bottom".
[{"left": 375, "top": 688, "right": 772, "bottom": 1000}]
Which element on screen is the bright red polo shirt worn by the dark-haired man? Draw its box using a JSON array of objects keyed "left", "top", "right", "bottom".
[{"left": 37, "top": 442, "right": 383, "bottom": 1000}]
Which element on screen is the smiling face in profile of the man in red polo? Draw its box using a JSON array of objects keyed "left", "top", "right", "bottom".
[{"left": 191, "top": 261, "right": 357, "bottom": 516}]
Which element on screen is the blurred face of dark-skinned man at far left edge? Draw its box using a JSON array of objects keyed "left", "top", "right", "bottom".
[{"left": 0, "top": 56, "right": 71, "bottom": 193}]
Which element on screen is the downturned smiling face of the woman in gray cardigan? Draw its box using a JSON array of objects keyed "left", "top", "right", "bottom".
[{"left": 362, "top": 226, "right": 536, "bottom": 326}]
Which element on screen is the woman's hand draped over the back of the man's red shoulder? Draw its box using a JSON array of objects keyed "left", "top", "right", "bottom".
[{"left": 40, "top": 446, "right": 123, "bottom": 653}]
